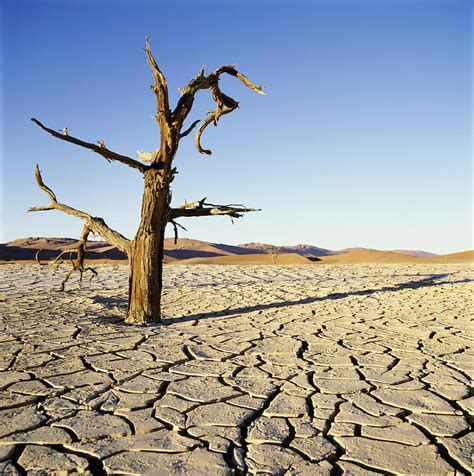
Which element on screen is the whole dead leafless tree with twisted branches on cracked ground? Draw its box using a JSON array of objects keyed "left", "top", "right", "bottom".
[{"left": 30, "top": 39, "right": 264, "bottom": 324}]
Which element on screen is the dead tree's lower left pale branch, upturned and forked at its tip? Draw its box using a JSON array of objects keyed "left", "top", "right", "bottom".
[{"left": 28, "top": 165, "right": 130, "bottom": 256}]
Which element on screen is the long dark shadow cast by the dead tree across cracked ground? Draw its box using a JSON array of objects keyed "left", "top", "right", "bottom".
[{"left": 90, "top": 273, "right": 474, "bottom": 325}]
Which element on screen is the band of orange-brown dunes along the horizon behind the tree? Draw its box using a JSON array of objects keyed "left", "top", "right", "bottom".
[{"left": 0, "top": 237, "right": 474, "bottom": 264}]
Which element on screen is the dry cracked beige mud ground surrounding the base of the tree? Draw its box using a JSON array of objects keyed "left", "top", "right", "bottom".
[{"left": 0, "top": 265, "right": 474, "bottom": 475}]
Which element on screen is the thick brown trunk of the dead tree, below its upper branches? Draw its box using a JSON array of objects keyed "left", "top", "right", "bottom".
[{"left": 125, "top": 170, "right": 169, "bottom": 324}]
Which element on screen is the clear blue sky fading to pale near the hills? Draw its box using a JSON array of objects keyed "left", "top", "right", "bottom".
[{"left": 0, "top": 0, "right": 473, "bottom": 253}]
